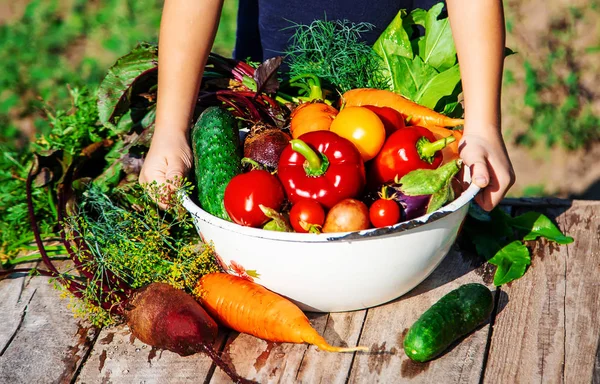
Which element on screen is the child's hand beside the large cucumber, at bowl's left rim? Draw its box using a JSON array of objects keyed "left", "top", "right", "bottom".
[{"left": 139, "top": 131, "right": 192, "bottom": 209}]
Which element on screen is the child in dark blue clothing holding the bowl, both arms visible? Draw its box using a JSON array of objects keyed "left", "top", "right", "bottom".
[{"left": 140, "top": 0, "right": 515, "bottom": 210}]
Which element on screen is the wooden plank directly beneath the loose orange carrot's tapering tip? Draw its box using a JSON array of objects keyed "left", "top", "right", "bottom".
[{"left": 211, "top": 311, "right": 364, "bottom": 383}]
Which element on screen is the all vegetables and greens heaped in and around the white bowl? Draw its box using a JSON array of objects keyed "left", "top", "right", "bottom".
[{"left": 0, "top": 4, "right": 572, "bottom": 376}]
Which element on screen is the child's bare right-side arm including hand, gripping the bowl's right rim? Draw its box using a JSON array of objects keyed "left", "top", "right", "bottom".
[{"left": 446, "top": 0, "right": 515, "bottom": 210}]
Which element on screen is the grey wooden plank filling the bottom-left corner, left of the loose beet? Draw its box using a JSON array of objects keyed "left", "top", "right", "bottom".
[{"left": 0, "top": 277, "right": 97, "bottom": 384}]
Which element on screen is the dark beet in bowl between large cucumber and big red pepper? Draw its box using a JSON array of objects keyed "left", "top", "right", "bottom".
[{"left": 244, "top": 124, "right": 292, "bottom": 170}]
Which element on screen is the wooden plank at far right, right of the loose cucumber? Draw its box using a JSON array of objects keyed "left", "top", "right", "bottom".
[{"left": 484, "top": 204, "right": 600, "bottom": 383}]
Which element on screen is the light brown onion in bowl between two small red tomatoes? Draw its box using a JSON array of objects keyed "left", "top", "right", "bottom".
[{"left": 323, "top": 199, "right": 371, "bottom": 233}]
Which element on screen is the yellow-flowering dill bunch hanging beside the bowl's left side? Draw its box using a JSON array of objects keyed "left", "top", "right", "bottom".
[{"left": 66, "top": 184, "right": 220, "bottom": 323}]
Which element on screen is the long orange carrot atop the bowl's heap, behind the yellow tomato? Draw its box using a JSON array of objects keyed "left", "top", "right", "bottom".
[{"left": 342, "top": 88, "right": 464, "bottom": 128}]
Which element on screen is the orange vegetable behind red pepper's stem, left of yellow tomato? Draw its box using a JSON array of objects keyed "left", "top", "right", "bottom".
[{"left": 290, "top": 102, "right": 338, "bottom": 139}]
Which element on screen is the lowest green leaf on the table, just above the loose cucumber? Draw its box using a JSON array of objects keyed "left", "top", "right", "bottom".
[{"left": 488, "top": 240, "right": 531, "bottom": 286}]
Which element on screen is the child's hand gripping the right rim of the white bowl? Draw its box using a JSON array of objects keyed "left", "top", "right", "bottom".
[{"left": 459, "top": 134, "right": 515, "bottom": 211}]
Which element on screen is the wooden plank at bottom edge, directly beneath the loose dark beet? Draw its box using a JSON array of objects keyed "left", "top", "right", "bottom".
[{"left": 76, "top": 325, "right": 224, "bottom": 384}]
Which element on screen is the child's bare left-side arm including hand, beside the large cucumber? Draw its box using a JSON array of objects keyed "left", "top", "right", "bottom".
[{"left": 139, "top": 0, "right": 223, "bottom": 198}]
